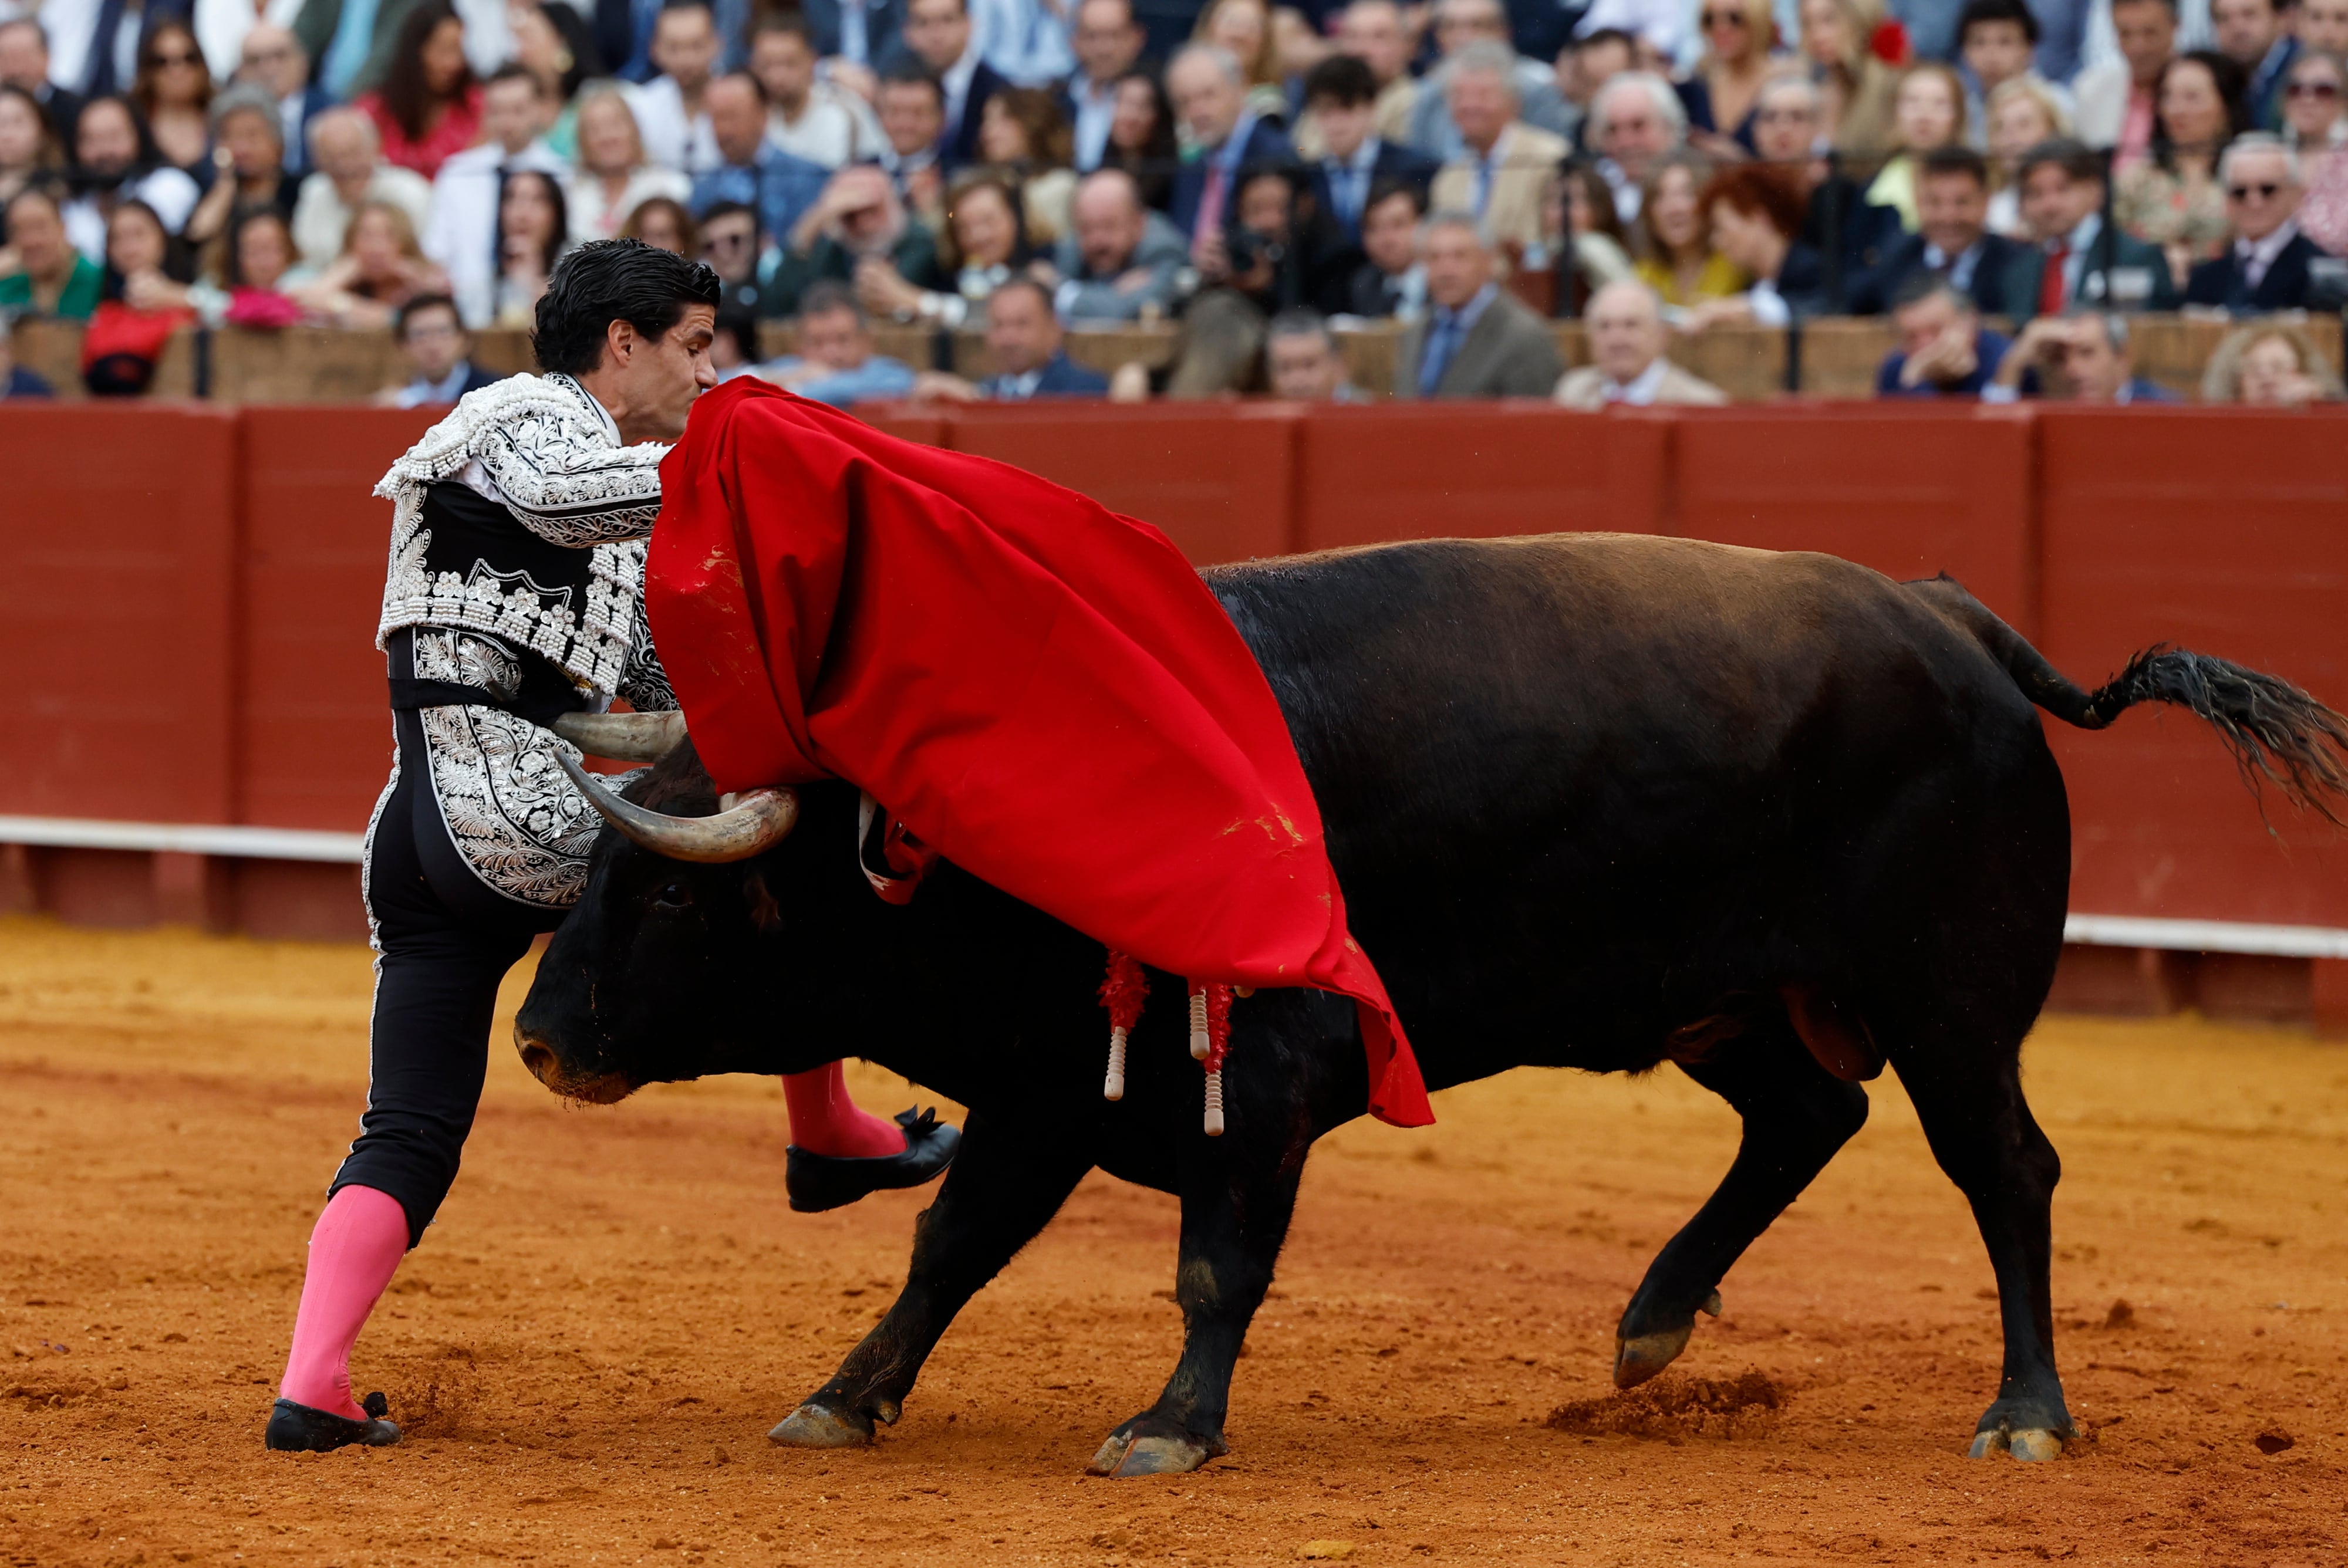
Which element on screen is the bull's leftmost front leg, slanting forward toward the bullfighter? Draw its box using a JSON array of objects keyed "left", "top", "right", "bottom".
[{"left": 768, "top": 1110, "right": 1092, "bottom": 1448}]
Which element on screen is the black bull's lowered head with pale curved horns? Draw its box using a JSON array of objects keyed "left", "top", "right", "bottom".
[{"left": 514, "top": 716, "right": 841, "bottom": 1103}]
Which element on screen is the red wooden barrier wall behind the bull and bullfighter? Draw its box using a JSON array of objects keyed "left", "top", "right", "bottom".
[{"left": 0, "top": 404, "right": 2348, "bottom": 967}]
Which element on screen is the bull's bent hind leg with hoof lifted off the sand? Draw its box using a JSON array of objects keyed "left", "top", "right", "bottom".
[{"left": 1615, "top": 1016, "right": 1867, "bottom": 1387}]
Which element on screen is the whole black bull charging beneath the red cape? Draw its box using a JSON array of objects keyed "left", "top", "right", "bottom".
[{"left": 517, "top": 535, "right": 2348, "bottom": 1474}]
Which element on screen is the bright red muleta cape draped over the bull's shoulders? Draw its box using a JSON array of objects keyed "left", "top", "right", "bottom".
[{"left": 643, "top": 376, "right": 1435, "bottom": 1127}]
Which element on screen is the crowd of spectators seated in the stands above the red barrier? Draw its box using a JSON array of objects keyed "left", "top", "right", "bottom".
[{"left": 0, "top": 0, "right": 2348, "bottom": 406}]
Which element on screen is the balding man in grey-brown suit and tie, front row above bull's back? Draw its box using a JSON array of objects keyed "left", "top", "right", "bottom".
[{"left": 1395, "top": 211, "right": 1566, "bottom": 399}]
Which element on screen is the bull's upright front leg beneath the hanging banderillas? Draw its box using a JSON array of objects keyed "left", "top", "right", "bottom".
[{"left": 1087, "top": 1124, "right": 1308, "bottom": 1476}]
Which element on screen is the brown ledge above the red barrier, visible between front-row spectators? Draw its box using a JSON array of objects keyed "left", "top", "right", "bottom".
[{"left": 14, "top": 315, "right": 2341, "bottom": 404}]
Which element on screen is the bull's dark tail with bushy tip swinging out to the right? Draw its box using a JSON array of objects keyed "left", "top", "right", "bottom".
[{"left": 1907, "top": 577, "right": 2348, "bottom": 826}]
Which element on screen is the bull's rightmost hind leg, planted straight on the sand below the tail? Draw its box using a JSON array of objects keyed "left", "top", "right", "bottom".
[{"left": 1892, "top": 1040, "right": 2071, "bottom": 1460}]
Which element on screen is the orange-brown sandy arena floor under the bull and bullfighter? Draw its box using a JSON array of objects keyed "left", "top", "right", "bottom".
[{"left": 0, "top": 920, "right": 2348, "bottom": 1568}]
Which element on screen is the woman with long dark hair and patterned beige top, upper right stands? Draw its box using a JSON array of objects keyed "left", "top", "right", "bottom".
[{"left": 2111, "top": 49, "right": 2252, "bottom": 289}]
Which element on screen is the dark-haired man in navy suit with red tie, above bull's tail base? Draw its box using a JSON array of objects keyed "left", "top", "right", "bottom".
[{"left": 2005, "top": 138, "right": 2177, "bottom": 322}]
